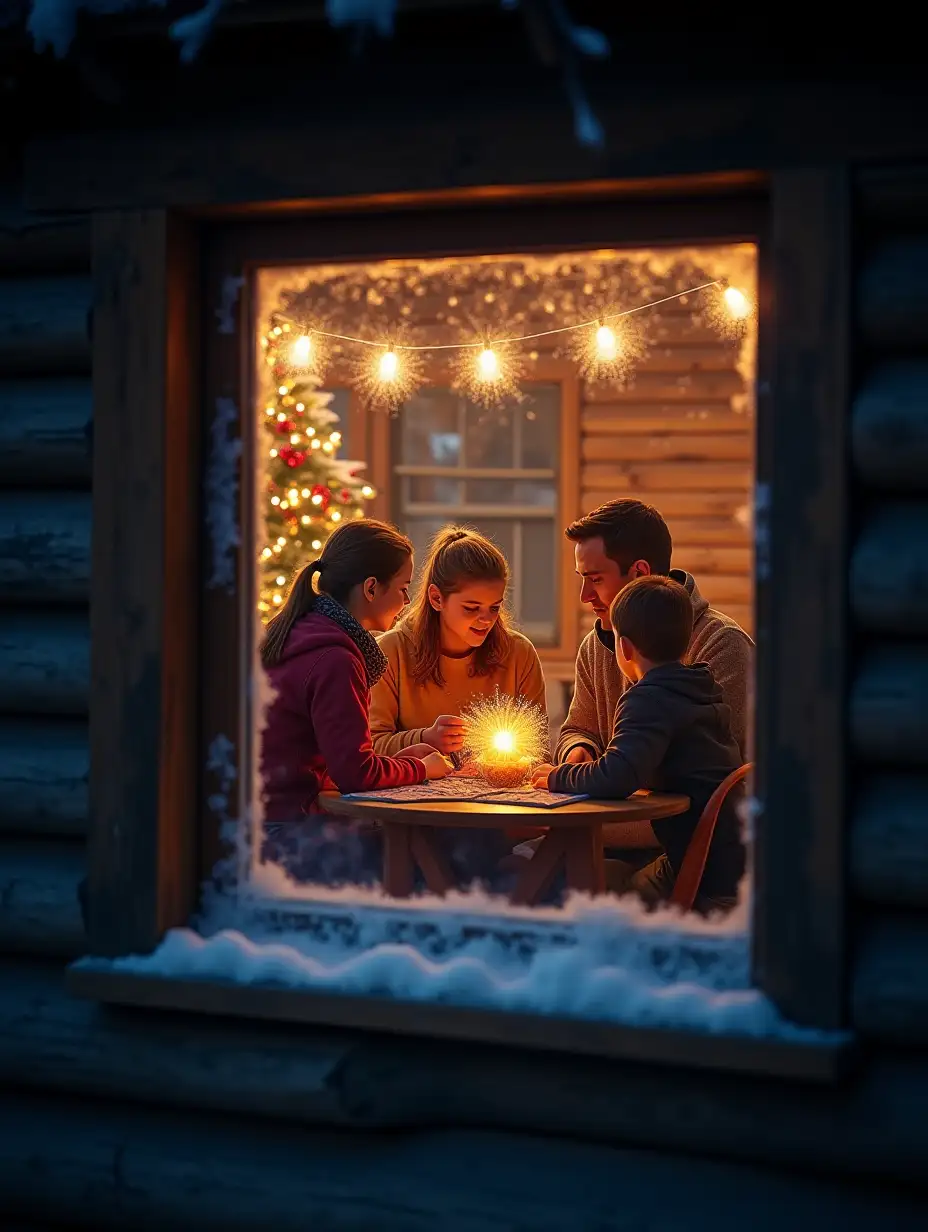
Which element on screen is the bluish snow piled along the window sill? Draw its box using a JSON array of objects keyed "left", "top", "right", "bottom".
[{"left": 81, "top": 892, "right": 838, "bottom": 1041}]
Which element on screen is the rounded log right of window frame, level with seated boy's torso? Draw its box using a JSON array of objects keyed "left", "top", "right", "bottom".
[{"left": 850, "top": 643, "right": 928, "bottom": 766}]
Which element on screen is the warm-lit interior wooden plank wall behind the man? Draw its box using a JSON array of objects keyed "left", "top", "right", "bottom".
[{"left": 580, "top": 306, "right": 754, "bottom": 633}]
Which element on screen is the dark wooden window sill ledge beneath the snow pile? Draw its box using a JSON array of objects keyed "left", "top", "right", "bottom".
[{"left": 67, "top": 963, "right": 855, "bottom": 1084}]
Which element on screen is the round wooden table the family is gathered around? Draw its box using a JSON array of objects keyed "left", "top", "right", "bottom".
[{"left": 319, "top": 791, "right": 690, "bottom": 906}]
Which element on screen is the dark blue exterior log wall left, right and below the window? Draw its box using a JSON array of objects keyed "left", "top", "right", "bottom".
[{"left": 0, "top": 144, "right": 928, "bottom": 1227}]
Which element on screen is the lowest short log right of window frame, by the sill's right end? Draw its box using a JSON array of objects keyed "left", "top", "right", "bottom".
[{"left": 853, "top": 915, "right": 928, "bottom": 1047}]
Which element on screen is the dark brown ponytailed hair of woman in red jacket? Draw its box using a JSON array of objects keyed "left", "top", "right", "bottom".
[{"left": 260, "top": 517, "right": 413, "bottom": 668}]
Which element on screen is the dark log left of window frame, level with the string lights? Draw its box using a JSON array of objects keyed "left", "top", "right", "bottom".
[{"left": 0, "top": 277, "right": 92, "bottom": 376}]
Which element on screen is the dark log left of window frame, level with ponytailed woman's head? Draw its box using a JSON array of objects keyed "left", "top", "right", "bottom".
[{"left": 0, "top": 492, "right": 90, "bottom": 604}]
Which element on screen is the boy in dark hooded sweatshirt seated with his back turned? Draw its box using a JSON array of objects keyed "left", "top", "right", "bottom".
[{"left": 534, "top": 575, "right": 744, "bottom": 912}]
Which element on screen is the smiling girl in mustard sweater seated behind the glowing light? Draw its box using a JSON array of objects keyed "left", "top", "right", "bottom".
[{"left": 371, "top": 526, "right": 545, "bottom": 756}]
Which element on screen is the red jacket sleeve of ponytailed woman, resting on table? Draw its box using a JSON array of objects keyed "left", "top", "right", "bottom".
[{"left": 307, "top": 647, "right": 425, "bottom": 796}]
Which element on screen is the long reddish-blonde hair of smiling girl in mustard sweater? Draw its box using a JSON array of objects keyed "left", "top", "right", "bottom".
[{"left": 403, "top": 526, "right": 513, "bottom": 686}]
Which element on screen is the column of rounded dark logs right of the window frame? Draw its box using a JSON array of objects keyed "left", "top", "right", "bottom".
[{"left": 849, "top": 166, "right": 928, "bottom": 1048}]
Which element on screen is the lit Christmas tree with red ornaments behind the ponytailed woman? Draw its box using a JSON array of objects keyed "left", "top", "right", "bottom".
[{"left": 258, "top": 323, "right": 375, "bottom": 621}]
